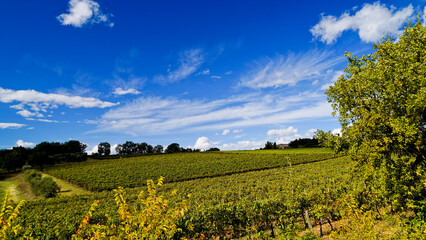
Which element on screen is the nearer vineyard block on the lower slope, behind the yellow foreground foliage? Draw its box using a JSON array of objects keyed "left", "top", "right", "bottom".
[{"left": 13, "top": 153, "right": 350, "bottom": 239}]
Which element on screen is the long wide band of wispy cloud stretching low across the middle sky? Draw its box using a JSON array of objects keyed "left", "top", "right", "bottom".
[{"left": 91, "top": 92, "right": 332, "bottom": 135}]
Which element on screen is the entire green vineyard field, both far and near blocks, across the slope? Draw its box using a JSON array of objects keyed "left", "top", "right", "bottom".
[{"left": 4, "top": 149, "right": 353, "bottom": 239}]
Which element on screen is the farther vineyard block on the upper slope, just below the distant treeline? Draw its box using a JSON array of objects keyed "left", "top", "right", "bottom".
[{"left": 45, "top": 149, "right": 342, "bottom": 191}]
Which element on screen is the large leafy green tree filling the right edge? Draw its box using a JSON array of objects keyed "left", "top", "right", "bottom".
[{"left": 326, "top": 19, "right": 426, "bottom": 210}]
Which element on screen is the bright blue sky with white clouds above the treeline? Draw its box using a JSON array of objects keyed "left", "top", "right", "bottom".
[{"left": 0, "top": 0, "right": 426, "bottom": 153}]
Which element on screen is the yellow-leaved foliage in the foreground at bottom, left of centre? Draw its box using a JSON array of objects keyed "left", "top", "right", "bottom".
[{"left": 73, "top": 178, "right": 187, "bottom": 239}]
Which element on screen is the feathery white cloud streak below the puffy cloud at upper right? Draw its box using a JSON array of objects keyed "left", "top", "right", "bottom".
[{"left": 239, "top": 50, "right": 344, "bottom": 89}]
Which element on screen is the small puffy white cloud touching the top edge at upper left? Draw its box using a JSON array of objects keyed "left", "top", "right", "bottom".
[{"left": 57, "top": 0, "right": 114, "bottom": 27}]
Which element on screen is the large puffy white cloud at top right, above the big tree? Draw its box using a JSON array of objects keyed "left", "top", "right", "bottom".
[{"left": 310, "top": 2, "right": 414, "bottom": 44}]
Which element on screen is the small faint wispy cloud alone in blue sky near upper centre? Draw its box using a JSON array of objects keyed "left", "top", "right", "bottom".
[{"left": 154, "top": 48, "right": 204, "bottom": 84}]
